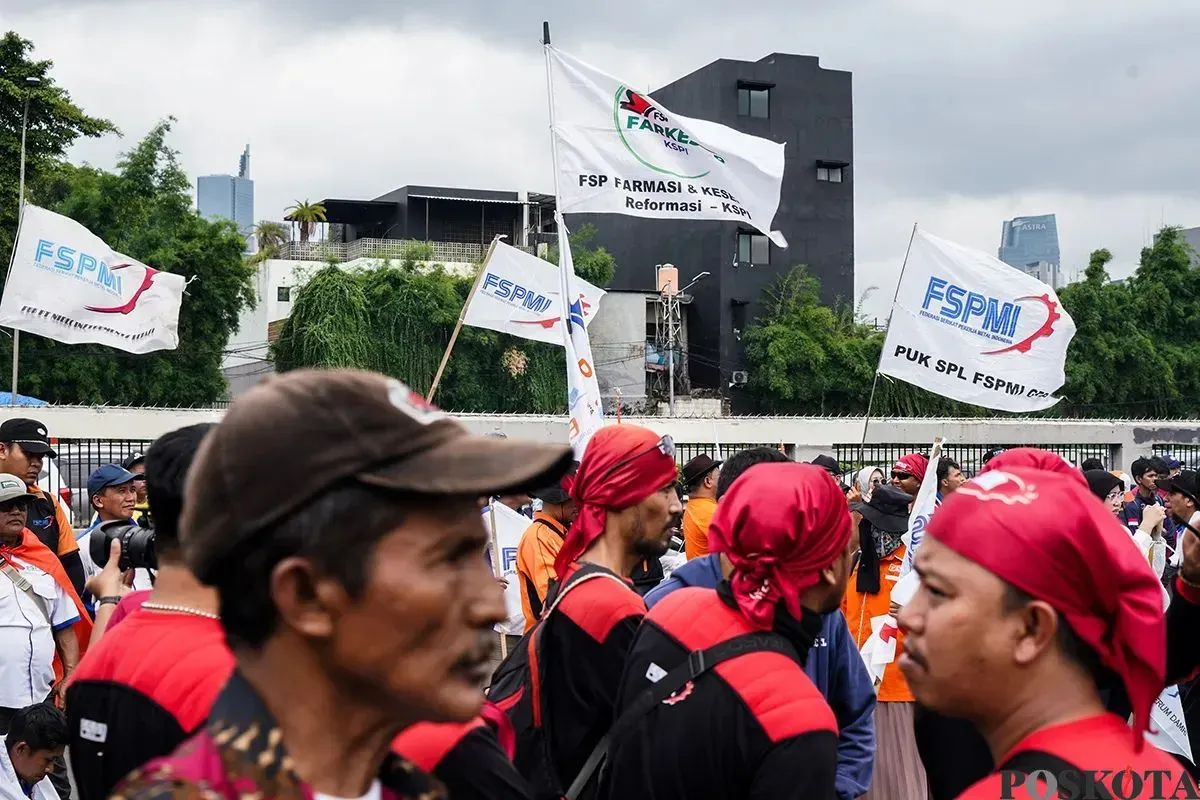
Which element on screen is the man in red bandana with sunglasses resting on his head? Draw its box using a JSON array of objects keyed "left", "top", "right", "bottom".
[{"left": 530, "top": 425, "right": 683, "bottom": 796}]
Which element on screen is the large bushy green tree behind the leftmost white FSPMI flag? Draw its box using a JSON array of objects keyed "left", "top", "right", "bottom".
[{"left": 17, "top": 120, "right": 254, "bottom": 405}]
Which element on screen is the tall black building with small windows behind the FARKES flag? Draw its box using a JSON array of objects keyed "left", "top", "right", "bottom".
[{"left": 568, "top": 53, "right": 854, "bottom": 411}]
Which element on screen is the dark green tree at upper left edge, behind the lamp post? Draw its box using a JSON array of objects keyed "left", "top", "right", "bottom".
[{"left": 0, "top": 31, "right": 116, "bottom": 275}]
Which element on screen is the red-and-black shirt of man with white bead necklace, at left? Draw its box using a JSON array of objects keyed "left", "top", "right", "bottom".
[{"left": 66, "top": 609, "right": 234, "bottom": 800}]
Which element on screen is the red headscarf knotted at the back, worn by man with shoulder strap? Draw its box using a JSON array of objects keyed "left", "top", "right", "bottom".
[{"left": 708, "top": 463, "right": 852, "bottom": 630}]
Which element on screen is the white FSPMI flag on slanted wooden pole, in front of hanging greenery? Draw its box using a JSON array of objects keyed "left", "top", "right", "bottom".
[{"left": 462, "top": 242, "right": 605, "bottom": 347}]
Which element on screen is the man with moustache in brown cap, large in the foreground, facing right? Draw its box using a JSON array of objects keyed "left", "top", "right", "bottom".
[{"left": 115, "top": 371, "right": 571, "bottom": 800}]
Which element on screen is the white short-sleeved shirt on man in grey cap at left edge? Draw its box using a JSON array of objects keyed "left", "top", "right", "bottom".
[{"left": 0, "top": 552, "right": 79, "bottom": 709}]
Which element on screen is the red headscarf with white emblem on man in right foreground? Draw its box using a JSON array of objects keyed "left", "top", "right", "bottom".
[{"left": 928, "top": 470, "right": 1166, "bottom": 751}]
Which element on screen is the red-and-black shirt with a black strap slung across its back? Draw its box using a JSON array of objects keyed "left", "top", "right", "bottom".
[{"left": 605, "top": 584, "right": 838, "bottom": 800}]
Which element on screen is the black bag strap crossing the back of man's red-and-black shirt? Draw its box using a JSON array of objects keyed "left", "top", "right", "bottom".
[{"left": 565, "top": 631, "right": 799, "bottom": 800}]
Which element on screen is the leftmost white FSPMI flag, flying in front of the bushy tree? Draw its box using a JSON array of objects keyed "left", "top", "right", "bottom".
[{"left": 0, "top": 204, "right": 186, "bottom": 353}]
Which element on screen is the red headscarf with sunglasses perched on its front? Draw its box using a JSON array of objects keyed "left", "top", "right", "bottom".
[{"left": 554, "top": 425, "right": 679, "bottom": 577}]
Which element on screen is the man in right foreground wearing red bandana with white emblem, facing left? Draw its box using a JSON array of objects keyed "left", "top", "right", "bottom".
[{"left": 899, "top": 464, "right": 1195, "bottom": 800}]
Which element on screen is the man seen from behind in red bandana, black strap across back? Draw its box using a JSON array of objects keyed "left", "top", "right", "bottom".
[{"left": 605, "top": 463, "right": 856, "bottom": 800}]
